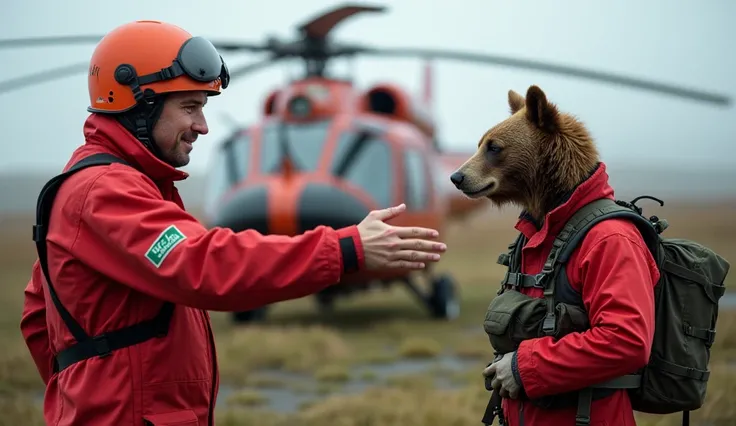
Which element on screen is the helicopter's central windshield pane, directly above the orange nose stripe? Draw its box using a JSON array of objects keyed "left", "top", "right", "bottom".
[{"left": 260, "top": 121, "right": 330, "bottom": 173}]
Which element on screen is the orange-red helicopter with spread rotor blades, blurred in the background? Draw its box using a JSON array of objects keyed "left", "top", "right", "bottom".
[{"left": 0, "top": 4, "right": 731, "bottom": 322}]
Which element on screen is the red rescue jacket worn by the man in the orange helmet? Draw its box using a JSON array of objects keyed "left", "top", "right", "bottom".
[{"left": 20, "top": 114, "right": 364, "bottom": 426}]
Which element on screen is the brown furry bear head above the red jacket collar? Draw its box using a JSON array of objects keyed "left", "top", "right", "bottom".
[{"left": 456, "top": 86, "right": 599, "bottom": 221}]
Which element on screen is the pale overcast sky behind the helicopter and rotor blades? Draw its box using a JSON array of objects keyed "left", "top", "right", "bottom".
[{"left": 0, "top": 0, "right": 736, "bottom": 172}]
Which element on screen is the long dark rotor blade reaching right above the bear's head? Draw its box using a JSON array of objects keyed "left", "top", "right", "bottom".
[{"left": 356, "top": 48, "right": 731, "bottom": 105}]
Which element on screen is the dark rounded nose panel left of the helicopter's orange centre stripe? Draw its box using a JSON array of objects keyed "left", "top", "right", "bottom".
[{"left": 210, "top": 186, "right": 268, "bottom": 234}]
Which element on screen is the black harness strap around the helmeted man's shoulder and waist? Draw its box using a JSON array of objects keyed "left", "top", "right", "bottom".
[{"left": 33, "top": 153, "right": 174, "bottom": 372}]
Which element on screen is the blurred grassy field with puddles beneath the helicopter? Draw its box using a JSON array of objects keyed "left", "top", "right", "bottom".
[{"left": 0, "top": 202, "right": 736, "bottom": 426}]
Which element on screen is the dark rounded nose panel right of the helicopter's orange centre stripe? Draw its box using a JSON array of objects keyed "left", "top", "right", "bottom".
[{"left": 297, "top": 183, "right": 370, "bottom": 232}]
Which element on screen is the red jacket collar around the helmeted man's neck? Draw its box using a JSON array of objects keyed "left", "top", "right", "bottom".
[{"left": 84, "top": 113, "right": 189, "bottom": 182}]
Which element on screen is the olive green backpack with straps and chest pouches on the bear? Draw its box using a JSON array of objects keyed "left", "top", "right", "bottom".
[{"left": 484, "top": 196, "right": 730, "bottom": 426}]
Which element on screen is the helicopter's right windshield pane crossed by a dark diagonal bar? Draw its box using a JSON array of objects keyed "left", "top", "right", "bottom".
[{"left": 331, "top": 131, "right": 393, "bottom": 208}]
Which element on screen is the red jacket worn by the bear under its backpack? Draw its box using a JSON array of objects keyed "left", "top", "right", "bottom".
[{"left": 502, "top": 163, "right": 659, "bottom": 426}]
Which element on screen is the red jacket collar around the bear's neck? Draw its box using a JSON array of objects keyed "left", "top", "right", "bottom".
[{"left": 515, "top": 162, "right": 614, "bottom": 247}]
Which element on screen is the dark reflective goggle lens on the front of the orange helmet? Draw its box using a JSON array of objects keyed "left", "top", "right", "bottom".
[{"left": 176, "top": 37, "right": 230, "bottom": 89}]
